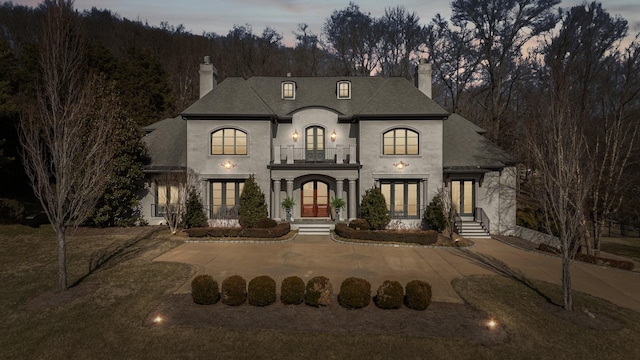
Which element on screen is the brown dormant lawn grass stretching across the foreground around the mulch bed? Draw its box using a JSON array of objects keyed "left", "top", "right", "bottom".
[{"left": 0, "top": 226, "right": 640, "bottom": 359}]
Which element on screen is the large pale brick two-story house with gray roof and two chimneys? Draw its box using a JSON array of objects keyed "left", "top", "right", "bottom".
[{"left": 143, "top": 61, "right": 515, "bottom": 233}]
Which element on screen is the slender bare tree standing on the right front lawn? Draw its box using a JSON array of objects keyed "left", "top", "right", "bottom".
[{"left": 527, "top": 49, "right": 592, "bottom": 310}]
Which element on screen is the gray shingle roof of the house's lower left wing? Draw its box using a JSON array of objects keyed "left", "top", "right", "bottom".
[{"left": 142, "top": 116, "right": 187, "bottom": 172}]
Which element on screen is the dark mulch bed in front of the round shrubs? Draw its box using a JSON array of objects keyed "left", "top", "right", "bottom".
[{"left": 144, "top": 294, "right": 508, "bottom": 345}]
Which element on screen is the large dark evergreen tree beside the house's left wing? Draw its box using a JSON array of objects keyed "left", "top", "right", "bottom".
[{"left": 86, "top": 115, "right": 147, "bottom": 227}]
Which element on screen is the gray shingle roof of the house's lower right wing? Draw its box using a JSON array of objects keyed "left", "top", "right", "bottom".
[{"left": 442, "top": 114, "right": 516, "bottom": 172}]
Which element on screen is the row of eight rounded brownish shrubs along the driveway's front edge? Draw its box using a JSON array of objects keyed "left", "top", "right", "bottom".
[{"left": 191, "top": 275, "right": 431, "bottom": 310}]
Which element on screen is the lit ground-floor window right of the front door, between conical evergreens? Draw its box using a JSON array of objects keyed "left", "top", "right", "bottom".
[{"left": 380, "top": 180, "right": 420, "bottom": 219}]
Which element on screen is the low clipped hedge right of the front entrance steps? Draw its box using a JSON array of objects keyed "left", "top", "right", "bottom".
[{"left": 335, "top": 219, "right": 438, "bottom": 245}]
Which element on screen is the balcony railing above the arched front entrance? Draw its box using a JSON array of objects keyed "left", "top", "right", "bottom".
[{"left": 272, "top": 145, "right": 356, "bottom": 164}]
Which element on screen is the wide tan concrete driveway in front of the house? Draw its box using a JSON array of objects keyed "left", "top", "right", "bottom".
[{"left": 155, "top": 235, "right": 640, "bottom": 312}]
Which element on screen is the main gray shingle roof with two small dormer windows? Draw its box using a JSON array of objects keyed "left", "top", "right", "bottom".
[{"left": 182, "top": 76, "right": 448, "bottom": 119}]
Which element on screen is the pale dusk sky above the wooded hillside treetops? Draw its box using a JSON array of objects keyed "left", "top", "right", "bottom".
[{"left": 13, "top": 0, "right": 640, "bottom": 45}]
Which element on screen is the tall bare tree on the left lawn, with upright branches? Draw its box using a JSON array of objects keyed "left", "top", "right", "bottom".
[{"left": 20, "top": 0, "right": 118, "bottom": 290}]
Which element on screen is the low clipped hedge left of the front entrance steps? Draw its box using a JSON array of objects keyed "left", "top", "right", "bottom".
[{"left": 185, "top": 219, "right": 291, "bottom": 238}]
